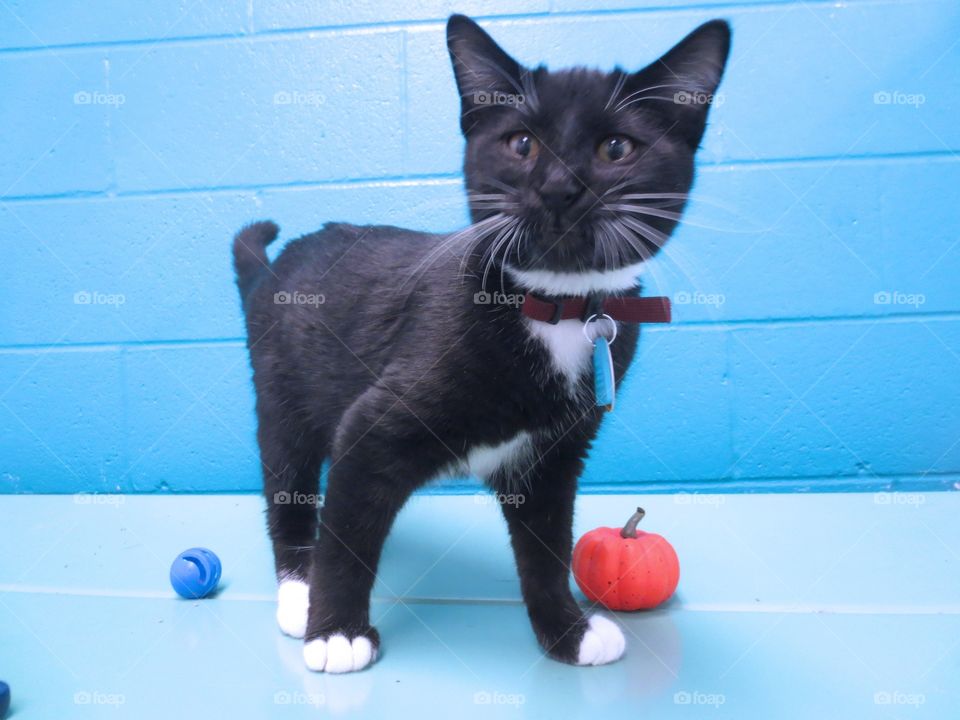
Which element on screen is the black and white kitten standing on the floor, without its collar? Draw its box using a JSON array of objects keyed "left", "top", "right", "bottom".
[{"left": 233, "top": 15, "right": 730, "bottom": 672}]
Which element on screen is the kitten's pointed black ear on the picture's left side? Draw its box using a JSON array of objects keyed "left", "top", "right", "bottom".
[{"left": 447, "top": 15, "right": 525, "bottom": 133}]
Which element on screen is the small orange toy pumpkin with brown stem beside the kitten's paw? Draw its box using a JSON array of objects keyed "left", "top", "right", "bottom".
[{"left": 573, "top": 508, "right": 680, "bottom": 610}]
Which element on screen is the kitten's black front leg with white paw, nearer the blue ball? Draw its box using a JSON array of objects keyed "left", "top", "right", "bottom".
[{"left": 303, "top": 388, "right": 440, "bottom": 673}]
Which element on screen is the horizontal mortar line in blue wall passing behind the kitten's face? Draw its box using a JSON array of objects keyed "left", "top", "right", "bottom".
[{"left": 0, "top": 150, "right": 960, "bottom": 205}]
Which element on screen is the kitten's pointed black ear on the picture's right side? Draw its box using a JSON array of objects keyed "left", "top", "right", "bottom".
[{"left": 621, "top": 20, "right": 730, "bottom": 148}]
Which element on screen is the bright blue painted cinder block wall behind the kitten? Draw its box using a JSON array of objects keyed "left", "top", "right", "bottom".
[{"left": 0, "top": 0, "right": 960, "bottom": 492}]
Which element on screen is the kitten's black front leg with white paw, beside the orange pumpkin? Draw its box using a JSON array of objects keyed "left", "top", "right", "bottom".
[{"left": 499, "top": 440, "right": 626, "bottom": 665}]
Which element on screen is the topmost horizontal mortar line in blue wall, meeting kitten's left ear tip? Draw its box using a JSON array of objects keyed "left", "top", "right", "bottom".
[{"left": 0, "top": 0, "right": 908, "bottom": 56}]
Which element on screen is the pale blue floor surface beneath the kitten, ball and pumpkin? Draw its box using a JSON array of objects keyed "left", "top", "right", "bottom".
[{"left": 0, "top": 493, "right": 960, "bottom": 720}]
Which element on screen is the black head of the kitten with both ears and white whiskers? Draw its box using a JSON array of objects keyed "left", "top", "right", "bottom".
[{"left": 447, "top": 15, "right": 730, "bottom": 282}]
